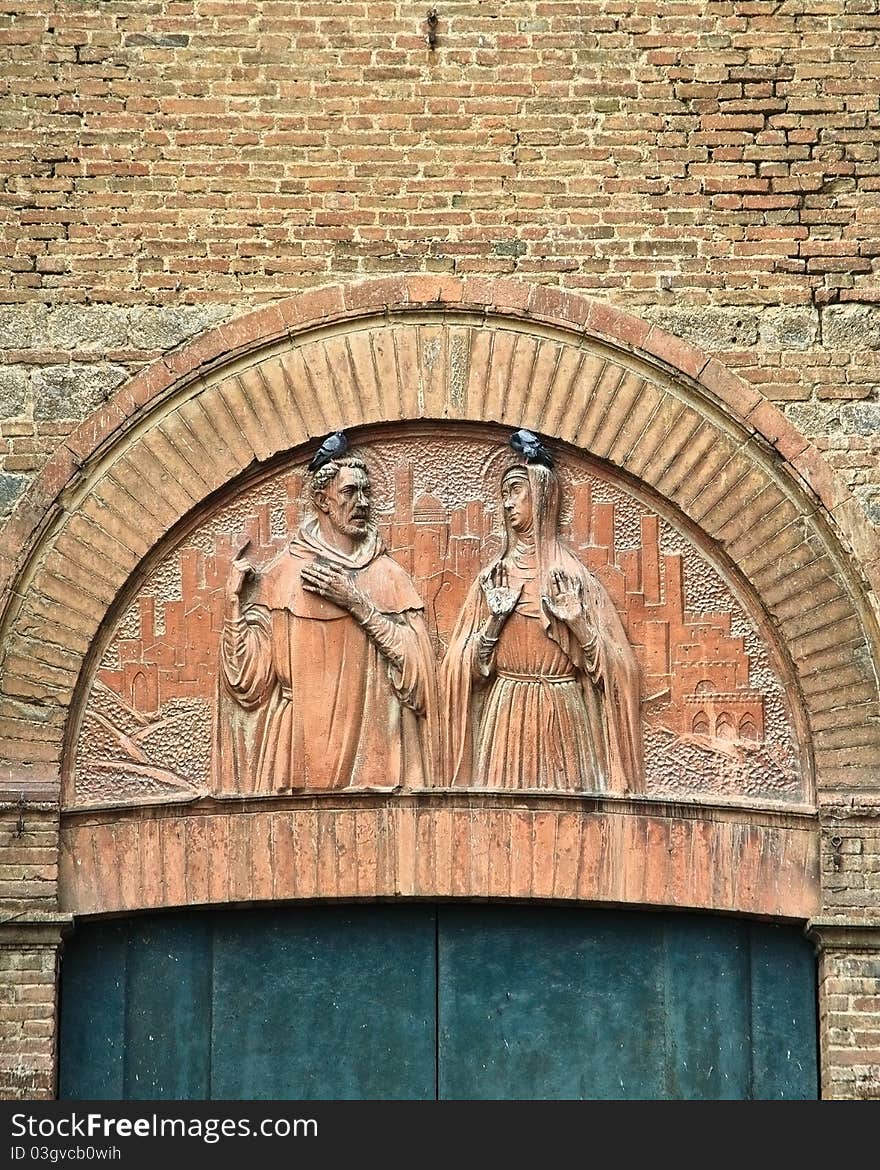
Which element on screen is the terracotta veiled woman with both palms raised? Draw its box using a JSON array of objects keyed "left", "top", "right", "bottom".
[{"left": 442, "top": 451, "right": 644, "bottom": 793}]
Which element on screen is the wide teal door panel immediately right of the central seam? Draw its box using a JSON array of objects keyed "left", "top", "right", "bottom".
[{"left": 439, "top": 908, "right": 664, "bottom": 1100}]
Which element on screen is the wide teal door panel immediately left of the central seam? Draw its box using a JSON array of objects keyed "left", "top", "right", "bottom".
[{"left": 212, "top": 907, "right": 435, "bottom": 1100}]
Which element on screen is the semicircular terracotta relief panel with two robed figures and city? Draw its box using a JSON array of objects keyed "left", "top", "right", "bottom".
[{"left": 67, "top": 426, "right": 807, "bottom": 806}]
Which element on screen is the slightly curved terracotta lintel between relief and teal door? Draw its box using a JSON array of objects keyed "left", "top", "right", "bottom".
[{"left": 60, "top": 793, "right": 820, "bottom": 920}]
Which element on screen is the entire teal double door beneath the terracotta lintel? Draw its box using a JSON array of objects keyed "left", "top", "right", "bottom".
[{"left": 60, "top": 906, "right": 817, "bottom": 1100}]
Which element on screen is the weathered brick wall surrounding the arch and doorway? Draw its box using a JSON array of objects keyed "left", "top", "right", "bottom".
[{"left": 0, "top": 0, "right": 880, "bottom": 1097}]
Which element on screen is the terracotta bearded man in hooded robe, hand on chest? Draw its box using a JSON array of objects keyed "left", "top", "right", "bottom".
[{"left": 218, "top": 455, "right": 436, "bottom": 792}]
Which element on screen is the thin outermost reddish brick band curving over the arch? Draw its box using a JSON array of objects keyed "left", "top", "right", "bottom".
[{"left": 0, "top": 275, "right": 880, "bottom": 617}]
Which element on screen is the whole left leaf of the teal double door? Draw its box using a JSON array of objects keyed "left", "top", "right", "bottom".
[{"left": 60, "top": 907, "right": 436, "bottom": 1100}]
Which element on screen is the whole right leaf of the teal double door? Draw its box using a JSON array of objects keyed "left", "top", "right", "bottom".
[{"left": 439, "top": 908, "right": 818, "bottom": 1100}]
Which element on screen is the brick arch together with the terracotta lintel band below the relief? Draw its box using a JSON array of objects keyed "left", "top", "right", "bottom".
[{"left": 0, "top": 277, "right": 880, "bottom": 1095}]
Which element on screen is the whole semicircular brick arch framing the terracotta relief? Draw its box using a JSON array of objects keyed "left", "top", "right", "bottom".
[{"left": 0, "top": 277, "right": 880, "bottom": 791}]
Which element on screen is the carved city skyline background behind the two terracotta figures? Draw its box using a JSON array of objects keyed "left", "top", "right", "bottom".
[{"left": 68, "top": 431, "right": 805, "bottom": 805}]
